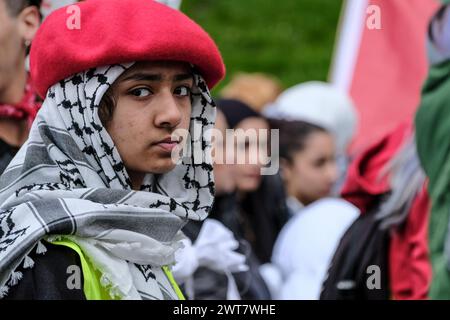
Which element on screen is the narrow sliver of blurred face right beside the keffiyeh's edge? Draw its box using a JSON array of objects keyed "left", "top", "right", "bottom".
[{"left": 212, "top": 111, "right": 236, "bottom": 195}]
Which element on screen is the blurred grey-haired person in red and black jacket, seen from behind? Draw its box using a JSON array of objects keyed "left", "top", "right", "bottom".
[{"left": 321, "top": 123, "right": 431, "bottom": 300}]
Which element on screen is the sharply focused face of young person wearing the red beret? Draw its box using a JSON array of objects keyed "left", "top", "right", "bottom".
[{"left": 104, "top": 61, "right": 194, "bottom": 187}]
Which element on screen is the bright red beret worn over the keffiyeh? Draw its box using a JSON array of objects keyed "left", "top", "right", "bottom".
[{"left": 30, "top": 0, "right": 225, "bottom": 97}]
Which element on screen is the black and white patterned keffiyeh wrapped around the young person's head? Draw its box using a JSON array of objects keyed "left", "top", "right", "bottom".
[{"left": 0, "top": 63, "right": 215, "bottom": 299}]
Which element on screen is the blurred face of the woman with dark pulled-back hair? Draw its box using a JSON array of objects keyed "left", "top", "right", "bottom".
[{"left": 283, "top": 132, "right": 338, "bottom": 205}]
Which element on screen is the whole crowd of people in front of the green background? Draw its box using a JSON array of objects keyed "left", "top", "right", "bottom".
[{"left": 0, "top": 0, "right": 450, "bottom": 300}]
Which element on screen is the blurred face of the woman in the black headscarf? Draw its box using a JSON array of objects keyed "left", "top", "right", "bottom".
[{"left": 230, "top": 117, "right": 269, "bottom": 192}]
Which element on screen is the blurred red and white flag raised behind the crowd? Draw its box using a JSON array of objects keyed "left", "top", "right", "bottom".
[{"left": 330, "top": 0, "right": 439, "bottom": 153}]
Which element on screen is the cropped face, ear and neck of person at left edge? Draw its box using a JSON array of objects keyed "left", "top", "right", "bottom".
[{"left": 0, "top": 0, "right": 40, "bottom": 104}]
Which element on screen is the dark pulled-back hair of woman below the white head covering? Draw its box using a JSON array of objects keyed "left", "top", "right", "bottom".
[{"left": 269, "top": 119, "right": 328, "bottom": 163}]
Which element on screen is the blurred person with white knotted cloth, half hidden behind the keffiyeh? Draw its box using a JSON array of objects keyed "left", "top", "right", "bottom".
[{"left": 177, "top": 109, "right": 271, "bottom": 300}]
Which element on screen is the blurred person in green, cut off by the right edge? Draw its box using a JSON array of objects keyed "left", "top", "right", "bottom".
[{"left": 415, "top": 4, "right": 450, "bottom": 299}]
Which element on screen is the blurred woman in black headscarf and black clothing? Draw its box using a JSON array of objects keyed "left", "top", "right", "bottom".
[{"left": 217, "top": 99, "right": 289, "bottom": 263}]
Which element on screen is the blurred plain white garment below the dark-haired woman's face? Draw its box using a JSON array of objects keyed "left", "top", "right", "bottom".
[{"left": 272, "top": 198, "right": 360, "bottom": 300}]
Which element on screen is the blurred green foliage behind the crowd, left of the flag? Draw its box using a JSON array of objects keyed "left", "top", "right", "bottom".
[{"left": 181, "top": 0, "right": 342, "bottom": 91}]
